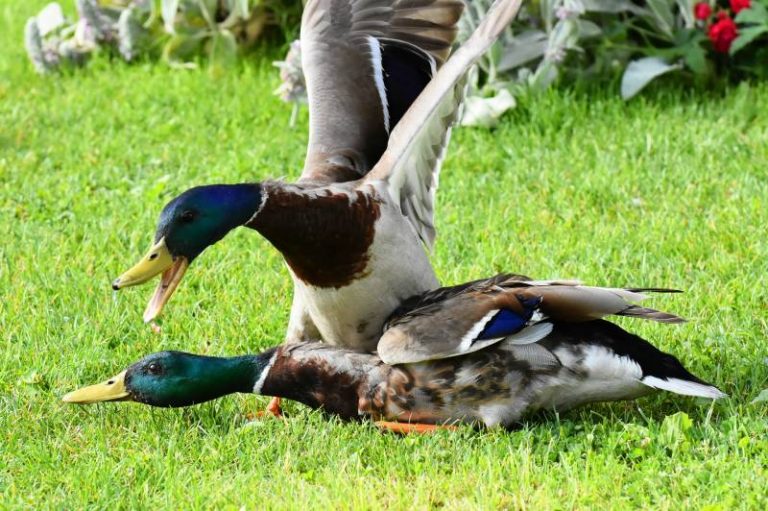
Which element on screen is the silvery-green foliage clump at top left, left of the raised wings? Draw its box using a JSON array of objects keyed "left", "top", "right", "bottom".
[{"left": 25, "top": 0, "right": 268, "bottom": 73}]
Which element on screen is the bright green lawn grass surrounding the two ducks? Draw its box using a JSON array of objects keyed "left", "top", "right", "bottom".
[{"left": 0, "top": 2, "right": 768, "bottom": 509}]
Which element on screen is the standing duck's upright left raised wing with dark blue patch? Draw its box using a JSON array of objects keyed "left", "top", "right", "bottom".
[{"left": 301, "top": 0, "right": 464, "bottom": 181}]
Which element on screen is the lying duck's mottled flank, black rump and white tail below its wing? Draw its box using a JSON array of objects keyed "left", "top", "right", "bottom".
[{"left": 373, "top": 320, "right": 725, "bottom": 427}]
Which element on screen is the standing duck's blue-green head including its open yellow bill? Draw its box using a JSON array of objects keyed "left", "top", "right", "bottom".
[{"left": 112, "top": 184, "right": 262, "bottom": 322}]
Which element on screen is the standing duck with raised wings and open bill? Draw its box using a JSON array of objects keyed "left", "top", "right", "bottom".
[{"left": 113, "top": 0, "right": 520, "bottom": 351}]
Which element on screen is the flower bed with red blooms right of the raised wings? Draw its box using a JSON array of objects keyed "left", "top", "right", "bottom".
[{"left": 452, "top": 0, "right": 768, "bottom": 124}]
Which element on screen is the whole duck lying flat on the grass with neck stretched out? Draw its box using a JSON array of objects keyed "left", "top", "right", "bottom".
[{"left": 63, "top": 275, "right": 725, "bottom": 432}]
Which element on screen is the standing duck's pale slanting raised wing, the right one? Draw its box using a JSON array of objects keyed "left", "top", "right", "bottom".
[{"left": 365, "top": 0, "right": 522, "bottom": 246}]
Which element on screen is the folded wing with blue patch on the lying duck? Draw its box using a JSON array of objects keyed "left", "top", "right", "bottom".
[{"left": 377, "top": 277, "right": 683, "bottom": 364}]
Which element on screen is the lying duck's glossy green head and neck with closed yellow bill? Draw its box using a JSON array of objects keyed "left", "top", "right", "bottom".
[{"left": 62, "top": 351, "right": 272, "bottom": 407}]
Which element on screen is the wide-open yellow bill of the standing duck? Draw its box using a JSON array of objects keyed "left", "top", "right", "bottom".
[{"left": 112, "top": 238, "right": 189, "bottom": 323}]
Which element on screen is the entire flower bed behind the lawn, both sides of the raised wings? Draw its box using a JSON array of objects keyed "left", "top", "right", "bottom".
[{"left": 26, "top": 0, "right": 768, "bottom": 114}]
